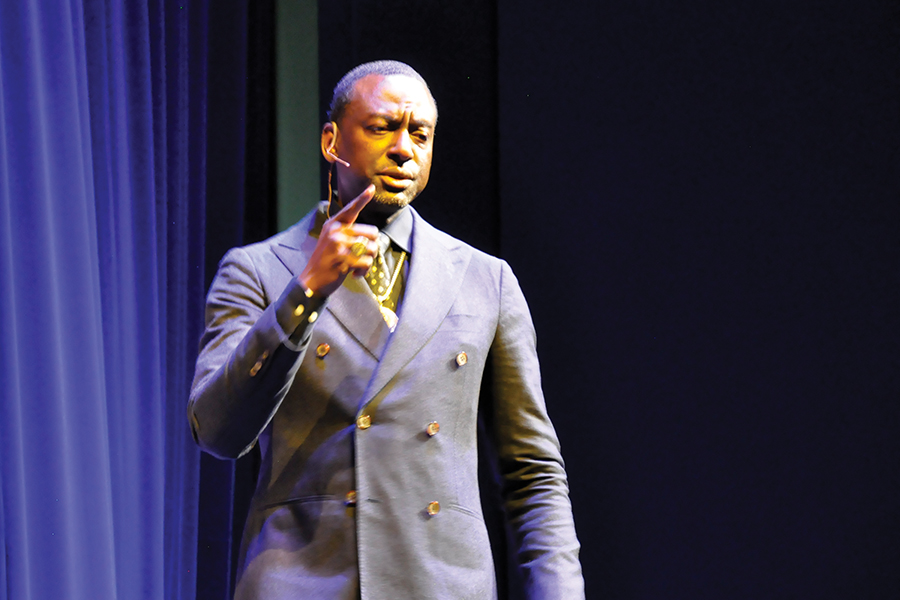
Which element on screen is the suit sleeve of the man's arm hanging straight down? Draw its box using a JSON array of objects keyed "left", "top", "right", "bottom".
[{"left": 490, "top": 262, "right": 584, "bottom": 600}]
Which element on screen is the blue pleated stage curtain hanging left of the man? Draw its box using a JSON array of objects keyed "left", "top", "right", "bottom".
[{"left": 0, "top": 0, "right": 208, "bottom": 600}]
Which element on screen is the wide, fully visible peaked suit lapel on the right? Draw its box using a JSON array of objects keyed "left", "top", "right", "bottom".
[{"left": 361, "top": 207, "right": 471, "bottom": 406}]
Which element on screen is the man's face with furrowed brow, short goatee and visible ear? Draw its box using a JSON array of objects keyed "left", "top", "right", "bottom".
[{"left": 323, "top": 75, "right": 437, "bottom": 213}]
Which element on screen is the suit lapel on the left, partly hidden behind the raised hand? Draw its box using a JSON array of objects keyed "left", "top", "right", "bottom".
[{"left": 272, "top": 211, "right": 390, "bottom": 359}]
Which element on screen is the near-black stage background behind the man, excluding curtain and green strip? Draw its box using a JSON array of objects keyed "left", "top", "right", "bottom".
[{"left": 198, "top": 0, "right": 900, "bottom": 599}]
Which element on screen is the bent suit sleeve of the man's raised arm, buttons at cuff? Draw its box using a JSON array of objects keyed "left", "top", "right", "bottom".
[{"left": 188, "top": 248, "right": 322, "bottom": 458}]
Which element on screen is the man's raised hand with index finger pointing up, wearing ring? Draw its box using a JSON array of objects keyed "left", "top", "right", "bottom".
[{"left": 299, "top": 185, "right": 378, "bottom": 296}]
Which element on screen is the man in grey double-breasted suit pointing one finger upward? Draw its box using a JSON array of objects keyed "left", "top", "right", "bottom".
[{"left": 189, "top": 61, "right": 584, "bottom": 600}]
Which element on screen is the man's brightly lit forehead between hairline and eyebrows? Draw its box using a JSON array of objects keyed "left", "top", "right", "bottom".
[{"left": 348, "top": 74, "right": 437, "bottom": 121}]
